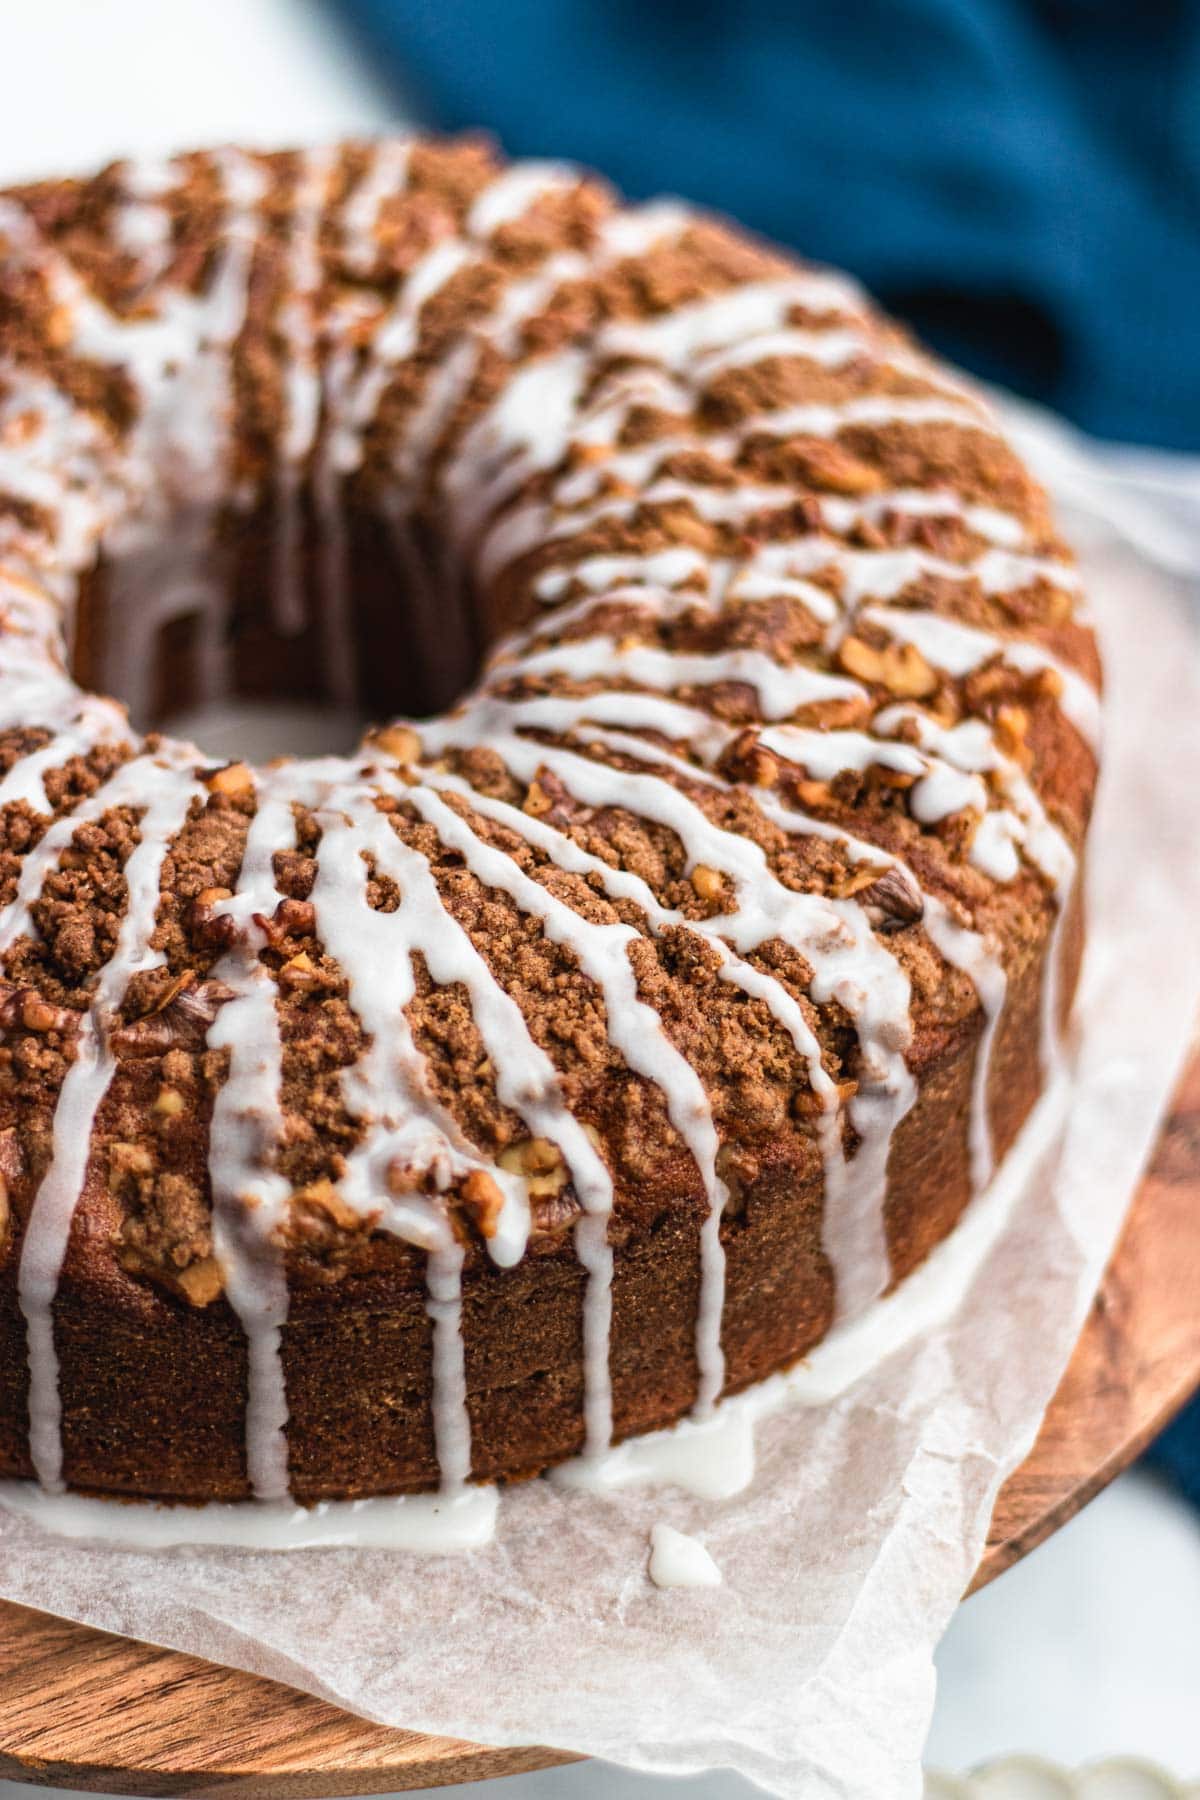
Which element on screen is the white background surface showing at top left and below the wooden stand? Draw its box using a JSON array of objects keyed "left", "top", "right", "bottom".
[{"left": 0, "top": 0, "right": 1200, "bottom": 1800}]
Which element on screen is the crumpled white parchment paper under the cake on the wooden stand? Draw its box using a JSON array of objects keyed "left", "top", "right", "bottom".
[{"left": 0, "top": 414, "right": 1200, "bottom": 1800}]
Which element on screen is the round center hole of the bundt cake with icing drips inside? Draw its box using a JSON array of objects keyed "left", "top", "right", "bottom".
[{"left": 72, "top": 491, "right": 477, "bottom": 761}]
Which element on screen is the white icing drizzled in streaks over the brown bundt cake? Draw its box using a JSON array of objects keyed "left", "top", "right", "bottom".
[{"left": 0, "top": 140, "right": 1099, "bottom": 1519}]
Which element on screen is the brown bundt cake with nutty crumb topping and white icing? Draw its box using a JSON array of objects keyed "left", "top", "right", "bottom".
[{"left": 0, "top": 139, "right": 1099, "bottom": 1501}]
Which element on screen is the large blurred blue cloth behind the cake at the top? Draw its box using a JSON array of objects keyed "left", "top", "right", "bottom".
[{"left": 335, "top": 0, "right": 1200, "bottom": 448}]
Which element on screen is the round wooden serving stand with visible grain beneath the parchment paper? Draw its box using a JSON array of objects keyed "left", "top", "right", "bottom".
[{"left": 0, "top": 1055, "right": 1200, "bottom": 1800}]
